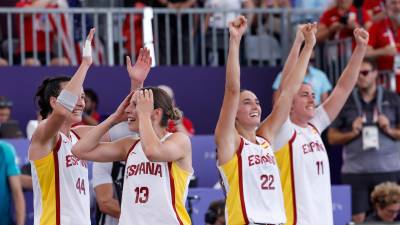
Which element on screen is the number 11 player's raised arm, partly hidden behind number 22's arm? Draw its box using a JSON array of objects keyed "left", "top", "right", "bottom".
[{"left": 274, "top": 25, "right": 304, "bottom": 102}]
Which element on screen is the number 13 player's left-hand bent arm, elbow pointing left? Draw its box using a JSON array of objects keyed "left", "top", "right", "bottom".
[{"left": 72, "top": 92, "right": 133, "bottom": 162}]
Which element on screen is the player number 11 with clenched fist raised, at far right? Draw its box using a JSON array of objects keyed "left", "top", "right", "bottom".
[{"left": 276, "top": 28, "right": 369, "bottom": 225}]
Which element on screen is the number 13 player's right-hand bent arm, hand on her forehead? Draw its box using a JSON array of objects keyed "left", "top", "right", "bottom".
[{"left": 134, "top": 89, "right": 191, "bottom": 169}]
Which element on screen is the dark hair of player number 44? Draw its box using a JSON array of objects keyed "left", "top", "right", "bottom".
[{"left": 35, "top": 76, "right": 71, "bottom": 119}]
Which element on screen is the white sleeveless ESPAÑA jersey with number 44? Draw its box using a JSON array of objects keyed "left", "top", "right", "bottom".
[{"left": 31, "top": 132, "right": 90, "bottom": 225}]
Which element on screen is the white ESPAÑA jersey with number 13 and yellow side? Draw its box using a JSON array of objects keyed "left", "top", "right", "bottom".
[{"left": 119, "top": 133, "right": 192, "bottom": 225}]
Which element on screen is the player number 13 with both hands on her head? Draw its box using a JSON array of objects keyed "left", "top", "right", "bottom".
[{"left": 72, "top": 87, "right": 193, "bottom": 225}]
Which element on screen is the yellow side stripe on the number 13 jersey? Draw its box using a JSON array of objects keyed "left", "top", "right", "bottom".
[{"left": 170, "top": 162, "right": 192, "bottom": 225}]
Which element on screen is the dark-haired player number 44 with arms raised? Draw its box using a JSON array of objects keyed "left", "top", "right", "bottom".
[{"left": 29, "top": 29, "right": 151, "bottom": 225}]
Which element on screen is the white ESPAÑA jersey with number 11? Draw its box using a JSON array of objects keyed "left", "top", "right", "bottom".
[{"left": 275, "top": 106, "right": 333, "bottom": 225}]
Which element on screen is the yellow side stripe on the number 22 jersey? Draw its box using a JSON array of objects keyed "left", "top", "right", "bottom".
[{"left": 220, "top": 154, "right": 246, "bottom": 225}]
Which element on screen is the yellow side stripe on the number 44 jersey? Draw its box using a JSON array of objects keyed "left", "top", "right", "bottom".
[{"left": 33, "top": 152, "right": 57, "bottom": 225}]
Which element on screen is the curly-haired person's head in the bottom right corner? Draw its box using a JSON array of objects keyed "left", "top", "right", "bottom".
[{"left": 366, "top": 182, "right": 400, "bottom": 222}]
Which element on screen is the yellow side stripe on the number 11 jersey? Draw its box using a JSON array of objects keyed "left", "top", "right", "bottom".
[{"left": 275, "top": 142, "right": 296, "bottom": 224}]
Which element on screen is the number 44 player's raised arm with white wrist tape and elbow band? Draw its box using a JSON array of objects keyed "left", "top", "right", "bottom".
[{"left": 29, "top": 28, "right": 95, "bottom": 159}]
